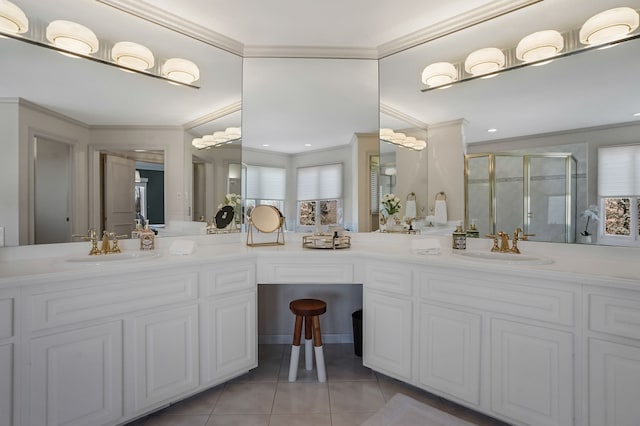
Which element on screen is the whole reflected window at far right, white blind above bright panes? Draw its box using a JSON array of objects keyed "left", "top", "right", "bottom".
[{"left": 598, "top": 145, "right": 640, "bottom": 246}]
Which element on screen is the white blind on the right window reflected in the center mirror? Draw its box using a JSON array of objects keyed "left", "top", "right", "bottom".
[{"left": 296, "top": 164, "right": 342, "bottom": 201}]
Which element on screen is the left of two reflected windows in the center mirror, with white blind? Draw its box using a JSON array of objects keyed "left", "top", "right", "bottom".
[{"left": 244, "top": 166, "right": 287, "bottom": 215}]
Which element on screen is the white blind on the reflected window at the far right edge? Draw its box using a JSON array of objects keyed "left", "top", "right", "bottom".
[{"left": 598, "top": 145, "right": 640, "bottom": 197}]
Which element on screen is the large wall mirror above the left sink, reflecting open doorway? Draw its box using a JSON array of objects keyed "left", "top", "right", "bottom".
[{"left": 0, "top": 0, "right": 242, "bottom": 245}]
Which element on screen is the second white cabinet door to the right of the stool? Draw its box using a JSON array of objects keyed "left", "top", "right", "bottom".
[{"left": 418, "top": 303, "right": 481, "bottom": 405}]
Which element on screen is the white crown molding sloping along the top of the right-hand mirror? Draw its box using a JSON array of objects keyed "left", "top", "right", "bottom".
[{"left": 378, "top": 0, "right": 543, "bottom": 59}]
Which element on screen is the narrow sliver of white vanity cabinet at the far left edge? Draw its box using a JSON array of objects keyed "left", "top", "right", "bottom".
[{"left": 0, "top": 290, "right": 19, "bottom": 426}]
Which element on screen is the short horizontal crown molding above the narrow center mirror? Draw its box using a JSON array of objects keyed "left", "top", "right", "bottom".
[{"left": 243, "top": 45, "right": 378, "bottom": 60}]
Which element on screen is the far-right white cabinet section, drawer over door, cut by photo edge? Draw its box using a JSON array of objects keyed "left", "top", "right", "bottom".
[{"left": 585, "top": 288, "right": 640, "bottom": 426}]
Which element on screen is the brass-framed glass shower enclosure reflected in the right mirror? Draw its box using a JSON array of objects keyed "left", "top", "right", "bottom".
[{"left": 465, "top": 153, "right": 576, "bottom": 243}]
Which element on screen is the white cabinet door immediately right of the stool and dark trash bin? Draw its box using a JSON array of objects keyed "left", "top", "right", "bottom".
[{"left": 363, "top": 289, "right": 413, "bottom": 380}]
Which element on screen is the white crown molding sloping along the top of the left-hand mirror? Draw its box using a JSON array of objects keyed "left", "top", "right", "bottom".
[{"left": 96, "top": 0, "right": 244, "bottom": 56}]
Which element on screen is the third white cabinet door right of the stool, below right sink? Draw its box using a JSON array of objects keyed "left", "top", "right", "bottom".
[{"left": 491, "top": 319, "right": 573, "bottom": 426}]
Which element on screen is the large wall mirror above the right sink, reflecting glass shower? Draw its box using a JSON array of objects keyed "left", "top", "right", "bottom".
[{"left": 380, "top": 1, "right": 640, "bottom": 242}]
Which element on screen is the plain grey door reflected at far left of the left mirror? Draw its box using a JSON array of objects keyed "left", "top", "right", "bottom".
[{"left": 34, "top": 137, "right": 71, "bottom": 244}]
